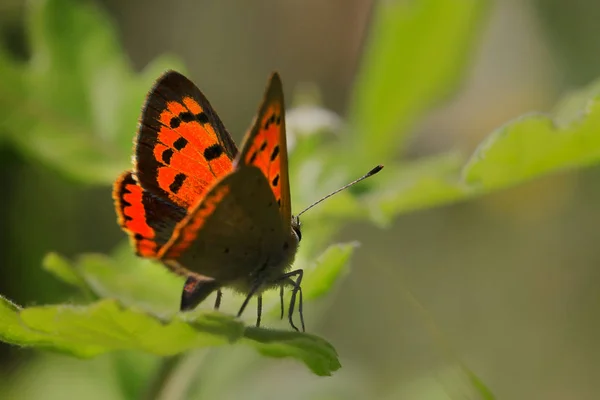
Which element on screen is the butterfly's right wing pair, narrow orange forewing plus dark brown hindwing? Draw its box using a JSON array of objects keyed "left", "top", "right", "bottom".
[{"left": 160, "top": 74, "right": 297, "bottom": 291}]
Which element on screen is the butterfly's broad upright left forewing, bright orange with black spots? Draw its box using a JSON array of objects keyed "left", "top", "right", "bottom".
[{"left": 134, "top": 71, "right": 237, "bottom": 210}]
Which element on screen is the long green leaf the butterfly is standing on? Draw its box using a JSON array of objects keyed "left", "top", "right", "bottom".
[{"left": 0, "top": 298, "right": 339, "bottom": 375}]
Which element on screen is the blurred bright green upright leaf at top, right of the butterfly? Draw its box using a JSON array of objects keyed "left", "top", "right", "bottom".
[{"left": 348, "top": 0, "right": 488, "bottom": 167}]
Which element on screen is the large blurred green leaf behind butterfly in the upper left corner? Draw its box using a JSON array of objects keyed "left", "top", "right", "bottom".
[{"left": 0, "top": 0, "right": 185, "bottom": 184}]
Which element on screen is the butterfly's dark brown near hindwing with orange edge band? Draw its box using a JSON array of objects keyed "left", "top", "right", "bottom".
[{"left": 161, "top": 167, "right": 288, "bottom": 286}]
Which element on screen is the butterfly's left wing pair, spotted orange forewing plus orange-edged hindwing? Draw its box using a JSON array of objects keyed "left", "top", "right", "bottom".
[{"left": 113, "top": 71, "right": 237, "bottom": 257}]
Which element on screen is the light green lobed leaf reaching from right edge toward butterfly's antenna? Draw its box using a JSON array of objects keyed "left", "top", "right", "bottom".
[{"left": 364, "top": 81, "right": 600, "bottom": 224}]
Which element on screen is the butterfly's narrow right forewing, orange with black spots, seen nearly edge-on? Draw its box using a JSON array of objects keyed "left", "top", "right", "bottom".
[{"left": 234, "top": 73, "right": 292, "bottom": 232}]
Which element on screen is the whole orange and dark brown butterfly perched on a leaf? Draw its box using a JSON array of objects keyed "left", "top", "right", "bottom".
[{"left": 113, "top": 71, "right": 382, "bottom": 330}]
